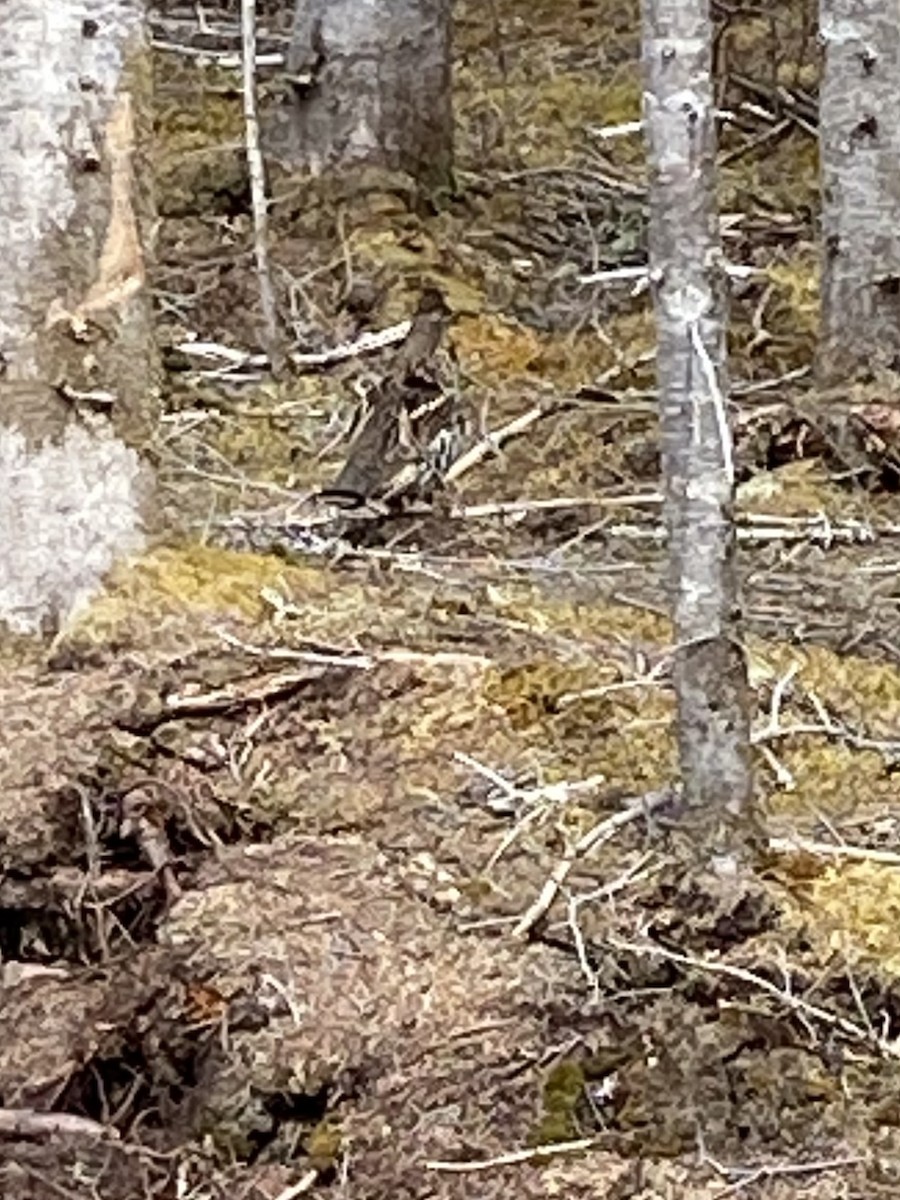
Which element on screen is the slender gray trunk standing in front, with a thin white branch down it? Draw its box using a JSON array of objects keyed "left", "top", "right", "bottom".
[{"left": 643, "top": 0, "right": 752, "bottom": 863}]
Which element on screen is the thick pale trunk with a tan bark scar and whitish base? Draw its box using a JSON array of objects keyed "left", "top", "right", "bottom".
[{"left": 0, "top": 0, "right": 156, "bottom": 632}]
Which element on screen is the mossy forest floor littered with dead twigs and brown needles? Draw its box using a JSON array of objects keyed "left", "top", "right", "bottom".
[{"left": 0, "top": 0, "right": 900, "bottom": 1200}]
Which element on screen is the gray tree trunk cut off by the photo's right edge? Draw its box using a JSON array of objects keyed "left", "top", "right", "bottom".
[{"left": 817, "top": 0, "right": 900, "bottom": 384}]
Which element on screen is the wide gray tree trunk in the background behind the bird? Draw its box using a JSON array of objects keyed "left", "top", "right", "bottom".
[{"left": 266, "top": 0, "right": 452, "bottom": 190}]
